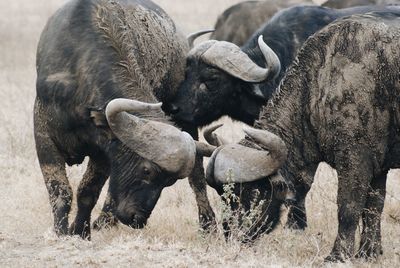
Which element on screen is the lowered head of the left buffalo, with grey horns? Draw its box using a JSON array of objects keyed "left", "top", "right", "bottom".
[{"left": 106, "top": 99, "right": 212, "bottom": 228}]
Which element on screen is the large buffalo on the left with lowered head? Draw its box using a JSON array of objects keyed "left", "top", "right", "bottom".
[{"left": 34, "top": 0, "right": 216, "bottom": 237}]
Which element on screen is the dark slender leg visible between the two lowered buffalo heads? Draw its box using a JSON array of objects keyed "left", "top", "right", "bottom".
[{"left": 189, "top": 155, "right": 216, "bottom": 230}]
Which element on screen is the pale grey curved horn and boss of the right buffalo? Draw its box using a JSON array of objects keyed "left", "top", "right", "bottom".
[{"left": 206, "top": 128, "right": 287, "bottom": 185}]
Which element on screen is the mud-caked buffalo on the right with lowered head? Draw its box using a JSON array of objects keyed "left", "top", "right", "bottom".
[{"left": 207, "top": 9, "right": 400, "bottom": 261}]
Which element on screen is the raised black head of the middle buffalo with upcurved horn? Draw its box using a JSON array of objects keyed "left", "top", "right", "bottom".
[{"left": 165, "top": 36, "right": 280, "bottom": 126}]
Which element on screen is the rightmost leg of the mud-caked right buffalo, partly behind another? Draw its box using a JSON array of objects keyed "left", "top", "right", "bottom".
[{"left": 356, "top": 174, "right": 387, "bottom": 258}]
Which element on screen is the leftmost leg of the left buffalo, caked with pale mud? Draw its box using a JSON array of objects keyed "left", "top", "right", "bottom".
[{"left": 35, "top": 131, "right": 72, "bottom": 235}]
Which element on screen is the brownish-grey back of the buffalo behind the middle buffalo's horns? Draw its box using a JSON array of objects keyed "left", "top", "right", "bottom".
[{"left": 210, "top": 0, "right": 313, "bottom": 46}]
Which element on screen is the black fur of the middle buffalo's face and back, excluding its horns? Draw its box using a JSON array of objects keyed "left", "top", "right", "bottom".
[{"left": 167, "top": 6, "right": 400, "bottom": 126}]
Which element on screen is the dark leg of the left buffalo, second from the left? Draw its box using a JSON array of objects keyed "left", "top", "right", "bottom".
[{"left": 70, "top": 157, "right": 110, "bottom": 239}]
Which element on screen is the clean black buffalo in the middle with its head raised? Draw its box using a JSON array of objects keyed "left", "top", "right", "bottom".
[{"left": 167, "top": 6, "right": 395, "bottom": 129}]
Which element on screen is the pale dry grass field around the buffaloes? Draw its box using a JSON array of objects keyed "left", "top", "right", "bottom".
[{"left": 0, "top": 0, "right": 400, "bottom": 267}]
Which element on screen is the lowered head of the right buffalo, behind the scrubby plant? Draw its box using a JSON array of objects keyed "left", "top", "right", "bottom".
[{"left": 204, "top": 124, "right": 294, "bottom": 241}]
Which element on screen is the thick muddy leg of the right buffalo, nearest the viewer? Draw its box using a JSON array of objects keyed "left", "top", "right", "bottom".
[{"left": 325, "top": 150, "right": 372, "bottom": 261}]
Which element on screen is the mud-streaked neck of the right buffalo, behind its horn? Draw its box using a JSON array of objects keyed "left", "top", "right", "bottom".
[{"left": 255, "top": 57, "right": 323, "bottom": 184}]
